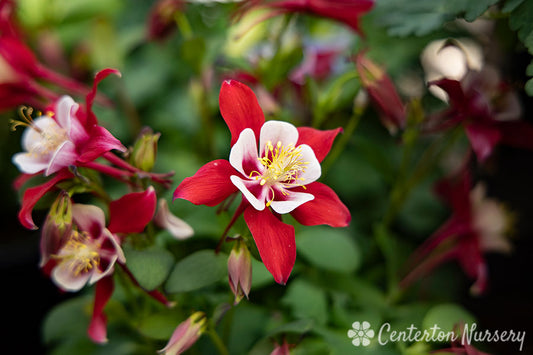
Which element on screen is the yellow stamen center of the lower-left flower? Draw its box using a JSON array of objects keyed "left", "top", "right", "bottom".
[{"left": 57, "top": 231, "right": 100, "bottom": 276}]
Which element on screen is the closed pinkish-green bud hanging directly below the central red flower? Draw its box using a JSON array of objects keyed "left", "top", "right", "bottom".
[{"left": 228, "top": 239, "right": 252, "bottom": 304}]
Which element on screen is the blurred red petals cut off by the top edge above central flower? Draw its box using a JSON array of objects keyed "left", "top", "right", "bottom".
[{"left": 235, "top": 0, "right": 374, "bottom": 34}]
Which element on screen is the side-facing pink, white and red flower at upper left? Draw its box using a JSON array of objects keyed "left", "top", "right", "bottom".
[{"left": 13, "top": 69, "right": 126, "bottom": 229}]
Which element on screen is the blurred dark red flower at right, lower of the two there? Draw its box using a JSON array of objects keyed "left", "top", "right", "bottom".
[{"left": 401, "top": 169, "right": 511, "bottom": 294}]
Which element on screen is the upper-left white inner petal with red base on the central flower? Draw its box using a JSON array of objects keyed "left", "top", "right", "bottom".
[{"left": 229, "top": 128, "right": 263, "bottom": 176}]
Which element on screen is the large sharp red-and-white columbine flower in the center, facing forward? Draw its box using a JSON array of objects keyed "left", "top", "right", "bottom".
[{"left": 174, "top": 80, "right": 351, "bottom": 284}]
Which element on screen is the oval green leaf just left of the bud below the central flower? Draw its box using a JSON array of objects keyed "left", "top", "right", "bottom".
[{"left": 165, "top": 250, "right": 227, "bottom": 293}]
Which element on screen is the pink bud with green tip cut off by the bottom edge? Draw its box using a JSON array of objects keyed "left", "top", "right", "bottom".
[{"left": 158, "top": 312, "right": 207, "bottom": 355}]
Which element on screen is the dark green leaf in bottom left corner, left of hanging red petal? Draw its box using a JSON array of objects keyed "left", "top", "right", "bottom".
[{"left": 43, "top": 297, "right": 92, "bottom": 344}]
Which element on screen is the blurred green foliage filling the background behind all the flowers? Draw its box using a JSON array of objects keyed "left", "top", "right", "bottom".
[{"left": 0, "top": 0, "right": 533, "bottom": 355}]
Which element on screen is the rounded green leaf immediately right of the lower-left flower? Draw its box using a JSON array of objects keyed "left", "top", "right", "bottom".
[{"left": 124, "top": 248, "right": 174, "bottom": 291}]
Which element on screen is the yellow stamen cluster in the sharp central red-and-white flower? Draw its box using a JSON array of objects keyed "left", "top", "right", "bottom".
[{"left": 256, "top": 141, "right": 309, "bottom": 187}]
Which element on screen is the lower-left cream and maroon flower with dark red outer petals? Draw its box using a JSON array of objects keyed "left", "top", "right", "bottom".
[{"left": 41, "top": 187, "right": 157, "bottom": 343}]
